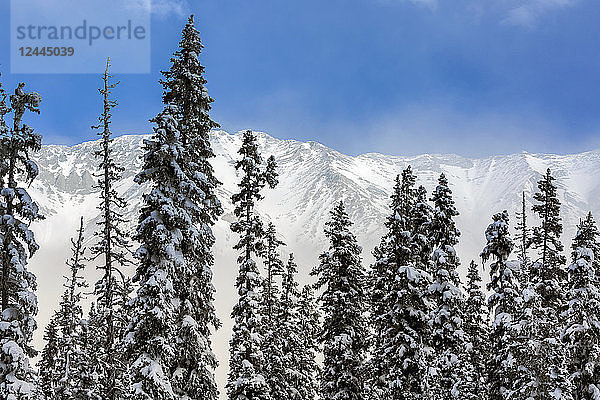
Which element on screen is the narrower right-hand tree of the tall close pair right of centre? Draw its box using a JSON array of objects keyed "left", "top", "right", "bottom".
[{"left": 428, "top": 174, "right": 464, "bottom": 400}]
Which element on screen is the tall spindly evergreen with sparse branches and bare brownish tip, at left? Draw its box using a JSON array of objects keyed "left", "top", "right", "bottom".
[{"left": 91, "top": 60, "right": 129, "bottom": 400}]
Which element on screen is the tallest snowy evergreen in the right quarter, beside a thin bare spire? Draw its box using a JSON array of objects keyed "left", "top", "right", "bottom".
[{"left": 529, "top": 169, "right": 572, "bottom": 400}]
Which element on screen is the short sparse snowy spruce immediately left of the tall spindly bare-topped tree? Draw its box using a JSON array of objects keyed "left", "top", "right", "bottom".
[{"left": 38, "top": 217, "right": 87, "bottom": 400}]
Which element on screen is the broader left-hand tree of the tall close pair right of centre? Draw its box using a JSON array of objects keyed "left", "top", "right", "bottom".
[{"left": 370, "top": 166, "right": 430, "bottom": 399}]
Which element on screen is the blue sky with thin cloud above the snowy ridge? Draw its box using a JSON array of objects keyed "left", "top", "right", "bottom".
[{"left": 0, "top": 0, "right": 600, "bottom": 156}]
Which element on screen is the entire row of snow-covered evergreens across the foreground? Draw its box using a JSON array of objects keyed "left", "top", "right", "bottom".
[{"left": 0, "top": 12, "right": 600, "bottom": 400}]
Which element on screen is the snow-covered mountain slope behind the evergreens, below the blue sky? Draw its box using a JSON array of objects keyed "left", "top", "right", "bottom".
[{"left": 25, "top": 131, "right": 600, "bottom": 394}]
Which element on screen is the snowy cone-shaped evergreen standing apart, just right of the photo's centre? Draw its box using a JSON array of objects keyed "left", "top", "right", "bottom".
[{"left": 312, "top": 201, "right": 367, "bottom": 400}]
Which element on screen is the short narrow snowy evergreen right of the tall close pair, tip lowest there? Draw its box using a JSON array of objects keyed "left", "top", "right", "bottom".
[{"left": 461, "top": 261, "right": 490, "bottom": 400}]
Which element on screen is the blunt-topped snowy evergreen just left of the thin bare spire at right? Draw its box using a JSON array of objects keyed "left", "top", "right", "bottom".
[{"left": 481, "top": 211, "right": 524, "bottom": 400}]
